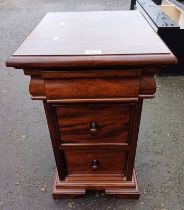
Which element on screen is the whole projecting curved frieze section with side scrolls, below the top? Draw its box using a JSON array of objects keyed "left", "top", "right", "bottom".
[{"left": 25, "top": 67, "right": 158, "bottom": 103}]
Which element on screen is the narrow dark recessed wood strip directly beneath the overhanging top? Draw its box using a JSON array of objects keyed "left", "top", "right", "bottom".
[{"left": 23, "top": 65, "right": 161, "bottom": 76}]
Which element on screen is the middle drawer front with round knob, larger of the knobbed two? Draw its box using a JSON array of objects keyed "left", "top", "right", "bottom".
[{"left": 56, "top": 104, "right": 132, "bottom": 143}]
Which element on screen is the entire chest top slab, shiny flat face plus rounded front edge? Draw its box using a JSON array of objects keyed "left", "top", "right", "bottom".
[{"left": 7, "top": 11, "right": 176, "bottom": 68}]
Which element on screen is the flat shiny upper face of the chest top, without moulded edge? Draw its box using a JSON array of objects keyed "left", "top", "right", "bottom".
[{"left": 14, "top": 11, "right": 170, "bottom": 56}]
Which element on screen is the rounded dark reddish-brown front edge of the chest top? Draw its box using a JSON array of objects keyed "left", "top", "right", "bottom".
[{"left": 6, "top": 53, "right": 177, "bottom": 69}]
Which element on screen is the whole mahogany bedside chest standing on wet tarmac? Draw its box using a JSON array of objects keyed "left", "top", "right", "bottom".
[{"left": 7, "top": 11, "right": 177, "bottom": 199}]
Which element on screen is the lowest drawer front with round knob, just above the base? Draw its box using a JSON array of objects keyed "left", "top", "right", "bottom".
[{"left": 65, "top": 150, "right": 127, "bottom": 175}]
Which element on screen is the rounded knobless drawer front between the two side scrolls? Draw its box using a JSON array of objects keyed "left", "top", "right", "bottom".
[{"left": 45, "top": 78, "right": 139, "bottom": 100}]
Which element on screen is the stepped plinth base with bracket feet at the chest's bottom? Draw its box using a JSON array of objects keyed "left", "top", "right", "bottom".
[{"left": 52, "top": 171, "right": 140, "bottom": 199}]
